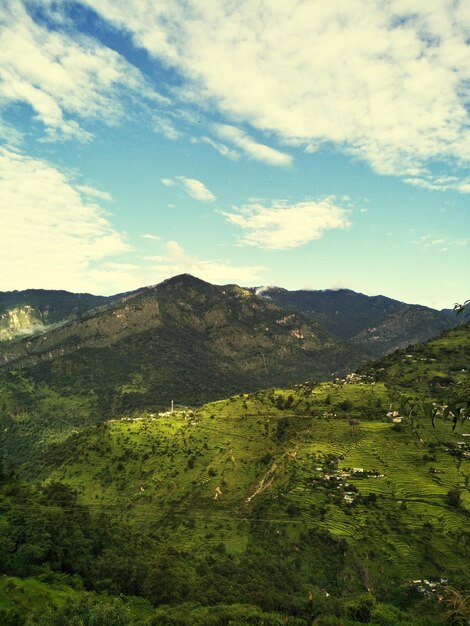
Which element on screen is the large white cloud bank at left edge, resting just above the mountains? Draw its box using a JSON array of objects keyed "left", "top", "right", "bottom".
[{"left": 0, "top": 148, "right": 129, "bottom": 291}]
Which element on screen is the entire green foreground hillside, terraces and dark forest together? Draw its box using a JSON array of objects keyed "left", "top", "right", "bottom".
[{"left": 0, "top": 325, "right": 470, "bottom": 626}]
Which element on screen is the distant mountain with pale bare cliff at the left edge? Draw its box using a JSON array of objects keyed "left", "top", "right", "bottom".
[{"left": 0, "top": 289, "right": 110, "bottom": 341}]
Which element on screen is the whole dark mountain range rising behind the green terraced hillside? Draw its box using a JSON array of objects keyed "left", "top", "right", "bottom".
[{"left": 0, "top": 274, "right": 460, "bottom": 415}]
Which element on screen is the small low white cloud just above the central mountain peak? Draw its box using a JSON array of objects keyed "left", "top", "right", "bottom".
[{"left": 147, "top": 241, "right": 265, "bottom": 284}]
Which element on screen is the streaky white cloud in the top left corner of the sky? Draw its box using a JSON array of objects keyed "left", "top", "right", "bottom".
[{"left": 0, "top": 0, "right": 167, "bottom": 141}]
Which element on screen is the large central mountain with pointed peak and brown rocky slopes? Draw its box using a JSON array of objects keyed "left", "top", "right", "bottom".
[{"left": 0, "top": 275, "right": 365, "bottom": 415}]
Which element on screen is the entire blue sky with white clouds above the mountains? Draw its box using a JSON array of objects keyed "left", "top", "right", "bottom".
[{"left": 0, "top": 0, "right": 470, "bottom": 308}]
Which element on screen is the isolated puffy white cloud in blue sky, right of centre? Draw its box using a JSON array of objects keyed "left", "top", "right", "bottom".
[{"left": 223, "top": 198, "right": 350, "bottom": 250}]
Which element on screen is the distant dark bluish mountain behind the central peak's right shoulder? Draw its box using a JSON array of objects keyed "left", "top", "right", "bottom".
[{"left": 254, "top": 287, "right": 458, "bottom": 356}]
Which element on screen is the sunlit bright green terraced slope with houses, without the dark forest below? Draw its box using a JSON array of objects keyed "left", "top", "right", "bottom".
[{"left": 0, "top": 326, "right": 470, "bottom": 620}]
